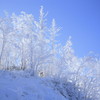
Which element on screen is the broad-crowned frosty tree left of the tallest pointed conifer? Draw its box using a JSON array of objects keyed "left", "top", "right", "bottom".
[{"left": 12, "top": 12, "right": 33, "bottom": 68}]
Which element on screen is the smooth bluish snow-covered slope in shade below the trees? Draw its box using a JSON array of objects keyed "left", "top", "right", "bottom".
[{"left": 0, "top": 71, "right": 66, "bottom": 100}]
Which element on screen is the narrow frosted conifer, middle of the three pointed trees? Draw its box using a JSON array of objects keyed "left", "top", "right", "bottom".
[{"left": 45, "top": 19, "right": 60, "bottom": 75}]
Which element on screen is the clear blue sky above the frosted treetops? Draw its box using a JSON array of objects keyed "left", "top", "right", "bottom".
[{"left": 0, "top": 0, "right": 100, "bottom": 57}]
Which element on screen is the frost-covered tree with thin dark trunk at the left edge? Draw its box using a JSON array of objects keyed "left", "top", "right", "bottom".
[{"left": 0, "top": 16, "right": 12, "bottom": 67}]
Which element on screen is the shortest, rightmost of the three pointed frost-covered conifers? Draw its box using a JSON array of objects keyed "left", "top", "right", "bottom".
[{"left": 61, "top": 37, "right": 79, "bottom": 78}]
